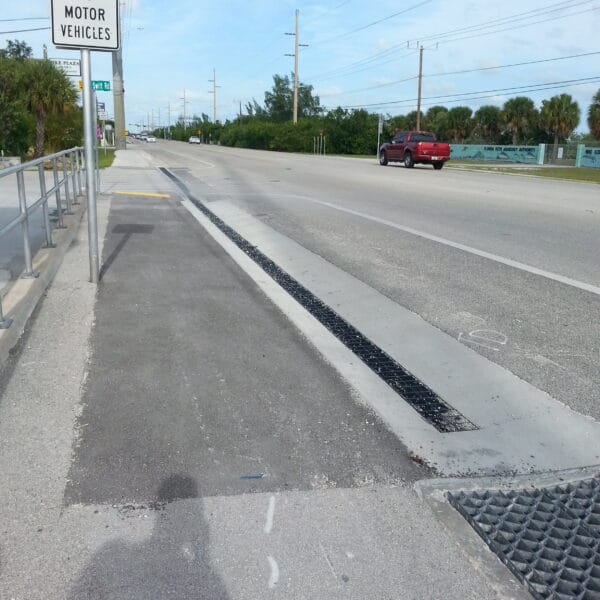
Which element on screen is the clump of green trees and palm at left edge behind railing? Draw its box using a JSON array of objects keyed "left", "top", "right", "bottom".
[{"left": 0, "top": 40, "right": 83, "bottom": 158}]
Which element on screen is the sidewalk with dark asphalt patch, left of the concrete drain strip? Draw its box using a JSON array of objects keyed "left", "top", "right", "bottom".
[{"left": 0, "top": 149, "right": 527, "bottom": 600}]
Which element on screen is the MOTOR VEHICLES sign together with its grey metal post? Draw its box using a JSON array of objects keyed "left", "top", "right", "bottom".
[{"left": 50, "top": 0, "right": 120, "bottom": 283}]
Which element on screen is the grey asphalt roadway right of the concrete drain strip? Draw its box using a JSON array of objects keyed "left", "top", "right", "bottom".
[{"left": 144, "top": 141, "right": 600, "bottom": 419}]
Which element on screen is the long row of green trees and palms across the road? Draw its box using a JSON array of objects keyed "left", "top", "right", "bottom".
[{"left": 154, "top": 75, "right": 600, "bottom": 157}]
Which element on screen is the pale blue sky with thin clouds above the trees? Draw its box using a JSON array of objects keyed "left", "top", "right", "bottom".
[{"left": 0, "top": 0, "right": 600, "bottom": 131}]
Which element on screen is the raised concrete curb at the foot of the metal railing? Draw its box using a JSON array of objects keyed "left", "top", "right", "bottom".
[{"left": 0, "top": 202, "right": 85, "bottom": 369}]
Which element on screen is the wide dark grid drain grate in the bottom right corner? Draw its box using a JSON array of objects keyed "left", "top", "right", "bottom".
[{"left": 448, "top": 479, "right": 600, "bottom": 600}]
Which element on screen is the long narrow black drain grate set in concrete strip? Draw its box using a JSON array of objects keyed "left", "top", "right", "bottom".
[{"left": 161, "top": 167, "right": 477, "bottom": 433}]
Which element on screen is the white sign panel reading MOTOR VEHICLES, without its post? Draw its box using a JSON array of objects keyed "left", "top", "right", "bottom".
[{"left": 50, "top": 0, "right": 119, "bottom": 51}]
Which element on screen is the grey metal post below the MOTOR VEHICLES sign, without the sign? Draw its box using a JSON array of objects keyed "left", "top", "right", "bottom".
[{"left": 81, "top": 50, "right": 100, "bottom": 283}]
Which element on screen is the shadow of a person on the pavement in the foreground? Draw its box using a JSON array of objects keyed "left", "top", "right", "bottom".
[{"left": 69, "top": 475, "right": 229, "bottom": 600}]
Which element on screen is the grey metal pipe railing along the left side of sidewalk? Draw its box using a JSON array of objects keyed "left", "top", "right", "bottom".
[{"left": 0, "top": 147, "right": 85, "bottom": 329}]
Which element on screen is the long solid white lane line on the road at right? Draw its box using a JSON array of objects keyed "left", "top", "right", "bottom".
[{"left": 306, "top": 197, "right": 600, "bottom": 296}]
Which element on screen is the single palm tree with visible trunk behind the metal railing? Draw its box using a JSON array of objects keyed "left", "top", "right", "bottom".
[{"left": 24, "top": 60, "right": 77, "bottom": 157}]
